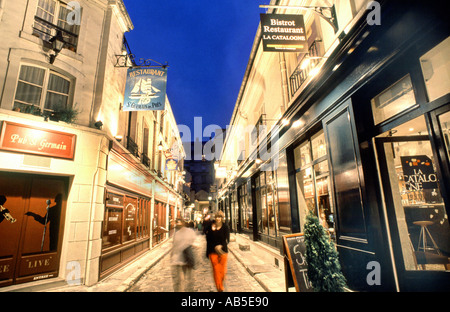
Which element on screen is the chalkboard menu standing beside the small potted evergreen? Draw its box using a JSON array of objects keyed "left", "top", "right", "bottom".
[{"left": 283, "top": 233, "right": 313, "bottom": 292}]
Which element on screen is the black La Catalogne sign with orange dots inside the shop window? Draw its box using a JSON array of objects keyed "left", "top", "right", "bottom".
[{"left": 400, "top": 155, "right": 438, "bottom": 191}]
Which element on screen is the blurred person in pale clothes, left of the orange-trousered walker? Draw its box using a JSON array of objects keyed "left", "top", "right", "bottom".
[{"left": 170, "top": 219, "right": 196, "bottom": 292}]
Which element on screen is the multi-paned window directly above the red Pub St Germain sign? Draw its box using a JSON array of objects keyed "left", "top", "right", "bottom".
[{"left": 14, "top": 65, "right": 71, "bottom": 116}]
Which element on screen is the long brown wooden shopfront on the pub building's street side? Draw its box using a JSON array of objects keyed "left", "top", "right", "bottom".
[{"left": 100, "top": 145, "right": 168, "bottom": 278}]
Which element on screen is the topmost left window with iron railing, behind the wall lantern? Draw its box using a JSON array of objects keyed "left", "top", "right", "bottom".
[{"left": 33, "top": 0, "right": 81, "bottom": 52}]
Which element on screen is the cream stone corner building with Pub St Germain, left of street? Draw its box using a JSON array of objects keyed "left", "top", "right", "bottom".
[{"left": 0, "top": 0, "right": 184, "bottom": 287}]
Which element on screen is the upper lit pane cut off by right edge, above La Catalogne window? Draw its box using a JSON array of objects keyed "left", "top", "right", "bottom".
[{"left": 420, "top": 37, "right": 450, "bottom": 101}]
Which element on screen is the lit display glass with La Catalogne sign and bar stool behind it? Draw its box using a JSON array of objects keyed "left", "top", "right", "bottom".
[{"left": 377, "top": 113, "right": 450, "bottom": 271}]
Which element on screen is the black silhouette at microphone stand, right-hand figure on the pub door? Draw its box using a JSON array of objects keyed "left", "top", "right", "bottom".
[{"left": 25, "top": 193, "right": 62, "bottom": 251}]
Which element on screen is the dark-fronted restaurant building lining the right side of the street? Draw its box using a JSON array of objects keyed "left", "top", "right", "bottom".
[{"left": 217, "top": 0, "right": 450, "bottom": 291}]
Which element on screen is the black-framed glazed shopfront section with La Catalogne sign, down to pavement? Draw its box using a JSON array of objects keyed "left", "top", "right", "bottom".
[{"left": 375, "top": 112, "right": 450, "bottom": 291}]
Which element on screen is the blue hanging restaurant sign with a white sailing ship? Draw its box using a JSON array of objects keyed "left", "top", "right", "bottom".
[{"left": 123, "top": 68, "right": 167, "bottom": 111}]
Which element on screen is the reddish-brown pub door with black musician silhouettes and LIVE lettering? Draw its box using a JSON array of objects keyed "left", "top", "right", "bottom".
[{"left": 0, "top": 172, "right": 67, "bottom": 287}]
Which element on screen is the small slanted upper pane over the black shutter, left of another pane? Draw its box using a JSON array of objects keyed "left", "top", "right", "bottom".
[{"left": 370, "top": 75, "right": 416, "bottom": 125}]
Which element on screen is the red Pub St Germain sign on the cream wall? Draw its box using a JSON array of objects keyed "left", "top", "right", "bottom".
[{"left": 0, "top": 121, "right": 76, "bottom": 159}]
